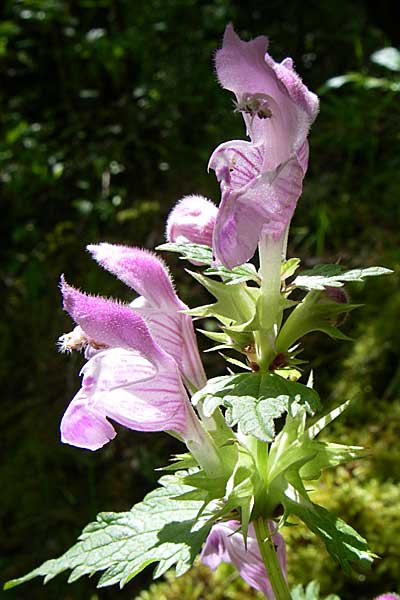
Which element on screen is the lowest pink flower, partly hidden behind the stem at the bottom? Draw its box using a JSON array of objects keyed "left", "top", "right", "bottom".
[{"left": 200, "top": 521, "right": 286, "bottom": 598}]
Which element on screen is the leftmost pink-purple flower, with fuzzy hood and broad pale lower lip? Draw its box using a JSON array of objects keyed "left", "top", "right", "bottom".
[{"left": 61, "top": 280, "right": 197, "bottom": 450}]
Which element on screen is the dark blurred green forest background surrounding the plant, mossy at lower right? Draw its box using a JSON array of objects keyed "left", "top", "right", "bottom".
[{"left": 0, "top": 0, "right": 400, "bottom": 600}]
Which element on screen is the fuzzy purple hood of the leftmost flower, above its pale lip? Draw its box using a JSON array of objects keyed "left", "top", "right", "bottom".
[{"left": 61, "top": 277, "right": 162, "bottom": 360}]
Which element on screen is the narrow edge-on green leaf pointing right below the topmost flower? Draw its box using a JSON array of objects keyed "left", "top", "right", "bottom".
[{"left": 293, "top": 265, "right": 393, "bottom": 290}]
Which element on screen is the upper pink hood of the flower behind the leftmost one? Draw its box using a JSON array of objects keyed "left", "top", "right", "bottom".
[{"left": 87, "top": 243, "right": 181, "bottom": 310}]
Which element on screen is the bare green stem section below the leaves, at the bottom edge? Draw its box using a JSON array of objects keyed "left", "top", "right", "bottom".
[{"left": 254, "top": 517, "right": 290, "bottom": 600}]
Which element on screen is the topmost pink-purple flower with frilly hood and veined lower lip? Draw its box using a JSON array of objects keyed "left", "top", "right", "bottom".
[{"left": 209, "top": 25, "right": 319, "bottom": 268}]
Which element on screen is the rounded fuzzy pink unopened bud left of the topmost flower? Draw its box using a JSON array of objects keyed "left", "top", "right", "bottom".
[{"left": 166, "top": 195, "right": 218, "bottom": 246}]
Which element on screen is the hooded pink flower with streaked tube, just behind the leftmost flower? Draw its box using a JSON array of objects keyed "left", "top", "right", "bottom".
[{"left": 88, "top": 243, "right": 206, "bottom": 388}]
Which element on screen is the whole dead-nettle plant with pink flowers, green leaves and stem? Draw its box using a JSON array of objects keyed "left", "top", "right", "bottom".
[{"left": 6, "top": 26, "right": 390, "bottom": 600}]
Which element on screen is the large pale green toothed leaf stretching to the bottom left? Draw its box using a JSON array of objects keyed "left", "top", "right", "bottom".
[{"left": 5, "top": 475, "right": 210, "bottom": 589}]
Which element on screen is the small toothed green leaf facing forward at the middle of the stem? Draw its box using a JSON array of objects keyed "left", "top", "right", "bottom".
[{"left": 192, "top": 373, "right": 320, "bottom": 442}]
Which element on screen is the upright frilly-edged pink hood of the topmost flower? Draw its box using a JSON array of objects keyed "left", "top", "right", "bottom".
[{"left": 216, "top": 25, "right": 319, "bottom": 170}]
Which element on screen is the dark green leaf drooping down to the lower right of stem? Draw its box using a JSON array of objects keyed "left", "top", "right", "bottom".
[{"left": 283, "top": 485, "right": 374, "bottom": 575}]
